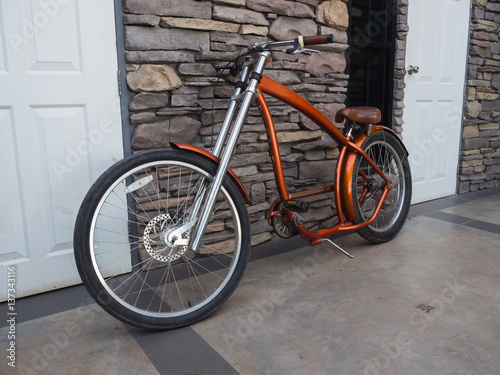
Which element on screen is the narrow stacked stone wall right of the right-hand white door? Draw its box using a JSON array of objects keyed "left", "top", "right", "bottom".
[{"left": 459, "top": 0, "right": 500, "bottom": 193}]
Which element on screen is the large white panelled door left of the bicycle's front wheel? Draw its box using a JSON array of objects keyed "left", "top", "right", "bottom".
[{"left": 0, "top": 0, "right": 123, "bottom": 300}]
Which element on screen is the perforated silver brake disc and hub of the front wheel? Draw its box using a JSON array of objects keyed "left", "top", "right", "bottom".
[{"left": 143, "top": 213, "right": 188, "bottom": 262}]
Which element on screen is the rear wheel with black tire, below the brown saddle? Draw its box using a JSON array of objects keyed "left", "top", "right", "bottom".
[{"left": 352, "top": 131, "right": 412, "bottom": 243}]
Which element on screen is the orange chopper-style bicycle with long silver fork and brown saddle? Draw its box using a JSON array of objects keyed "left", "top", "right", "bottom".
[{"left": 74, "top": 34, "right": 411, "bottom": 329}]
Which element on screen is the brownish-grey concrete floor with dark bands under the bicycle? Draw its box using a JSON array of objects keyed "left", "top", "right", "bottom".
[{"left": 0, "top": 188, "right": 500, "bottom": 375}]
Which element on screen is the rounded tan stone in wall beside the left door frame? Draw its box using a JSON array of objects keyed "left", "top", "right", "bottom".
[{"left": 127, "top": 65, "right": 182, "bottom": 92}]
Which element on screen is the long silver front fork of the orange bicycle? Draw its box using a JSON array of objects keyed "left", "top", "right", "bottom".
[{"left": 168, "top": 51, "right": 270, "bottom": 252}]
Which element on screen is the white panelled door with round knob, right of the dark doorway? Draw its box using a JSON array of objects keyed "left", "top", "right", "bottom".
[{"left": 403, "top": 0, "right": 470, "bottom": 203}]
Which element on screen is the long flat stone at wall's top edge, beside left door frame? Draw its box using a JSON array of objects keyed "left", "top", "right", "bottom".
[{"left": 123, "top": 0, "right": 212, "bottom": 19}]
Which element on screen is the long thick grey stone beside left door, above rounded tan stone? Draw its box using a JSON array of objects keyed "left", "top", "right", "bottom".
[{"left": 125, "top": 26, "right": 210, "bottom": 51}]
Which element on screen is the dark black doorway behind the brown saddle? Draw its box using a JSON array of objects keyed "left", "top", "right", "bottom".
[{"left": 347, "top": 0, "right": 397, "bottom": 127}]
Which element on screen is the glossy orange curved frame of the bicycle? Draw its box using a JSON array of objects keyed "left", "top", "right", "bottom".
[{"left": 256, "top": 76, "right": 391, "bottom": 242}]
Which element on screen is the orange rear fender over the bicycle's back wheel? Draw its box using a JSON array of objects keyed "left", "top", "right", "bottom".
[{"left": 340, "top": 125, "right": 408, "bottom": 222}]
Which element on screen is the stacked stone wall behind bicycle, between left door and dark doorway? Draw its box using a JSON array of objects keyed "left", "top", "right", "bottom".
[{"left": 124, "top": 0, "right": 349, "bottom": 245}]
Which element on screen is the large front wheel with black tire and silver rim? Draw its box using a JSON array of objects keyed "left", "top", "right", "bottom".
[{"left": 74, "top": 150, "right": 250, "bottom": 329}]
